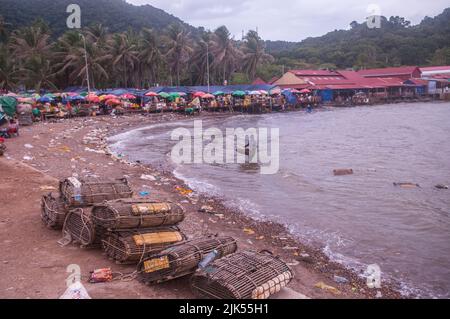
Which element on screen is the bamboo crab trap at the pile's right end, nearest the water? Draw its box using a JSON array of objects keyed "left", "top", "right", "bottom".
[{"left": 191, "top": 251, "right": 294, "bottom": 299}]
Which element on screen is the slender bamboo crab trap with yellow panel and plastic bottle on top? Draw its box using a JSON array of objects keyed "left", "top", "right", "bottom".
[{"left": 138, "top": 237, "right": 237, "bottom": 284}]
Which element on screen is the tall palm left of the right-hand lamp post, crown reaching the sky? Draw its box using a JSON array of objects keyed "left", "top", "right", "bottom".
[{"left": 165, "top": 24, "right": 193, "bottom": 86}]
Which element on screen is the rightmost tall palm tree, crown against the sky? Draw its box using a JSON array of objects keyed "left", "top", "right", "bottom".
[{"left": 242, "top": 31, "right": 274, "bottom": 80}]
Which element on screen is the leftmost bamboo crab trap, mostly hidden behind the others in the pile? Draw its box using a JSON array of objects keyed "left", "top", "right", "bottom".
[{"left": 41, "top": 193, "right": 69, "bottom": 229}]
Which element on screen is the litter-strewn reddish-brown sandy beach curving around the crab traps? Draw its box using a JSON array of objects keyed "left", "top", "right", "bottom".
[{"left": 0, "top": 114, "right": 402, "bottom": 299}]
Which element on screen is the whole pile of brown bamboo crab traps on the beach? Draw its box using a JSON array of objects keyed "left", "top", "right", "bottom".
[{"left": 41, "top": 177, "right": 294, "bottom": 299}]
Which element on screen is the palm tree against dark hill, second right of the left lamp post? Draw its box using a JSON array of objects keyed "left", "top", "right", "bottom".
[{"left": 107, "top": 31, "right": 139, "bottom": 87}]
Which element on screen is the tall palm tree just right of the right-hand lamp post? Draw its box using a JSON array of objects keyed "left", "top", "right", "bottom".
[{"left": 212, "top": 26, "right": 242, "bottom": 82}]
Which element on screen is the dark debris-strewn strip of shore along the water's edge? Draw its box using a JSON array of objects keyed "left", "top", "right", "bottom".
[{"left": 107, "top": 110, "right": 404, "bottom": 299}]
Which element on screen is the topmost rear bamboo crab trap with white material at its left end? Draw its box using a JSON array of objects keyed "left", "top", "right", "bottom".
[{"left": 59, "top": 177, "right": 133, "bottom": 208}]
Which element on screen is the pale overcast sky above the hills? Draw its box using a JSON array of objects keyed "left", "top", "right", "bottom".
[{"left": 127, "top": 0, "right": 450, "bottom": 41}]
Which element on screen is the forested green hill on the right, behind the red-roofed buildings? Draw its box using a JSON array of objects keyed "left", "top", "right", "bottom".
[{"left": 267, "top": 8, "right": 450, "bottom": 68}]
